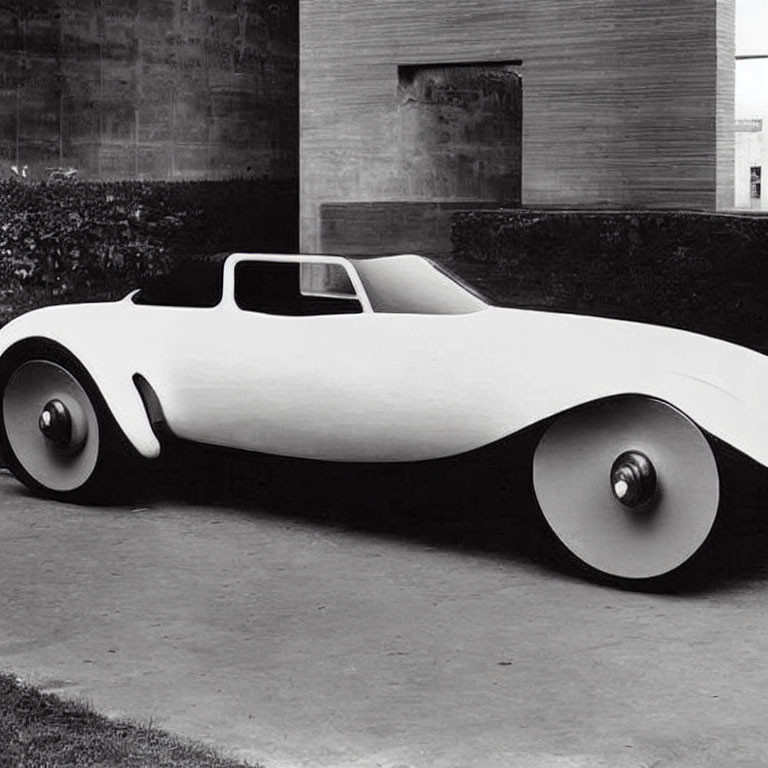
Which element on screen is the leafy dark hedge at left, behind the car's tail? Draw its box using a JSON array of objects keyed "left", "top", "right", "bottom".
[{"left": 0, "top": 180, "right": 298, "bottom": 325}]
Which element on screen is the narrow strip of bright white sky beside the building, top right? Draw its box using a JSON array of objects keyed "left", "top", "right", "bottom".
[{"left": 736, "top": 0, "right": 768, "bottom": 118}]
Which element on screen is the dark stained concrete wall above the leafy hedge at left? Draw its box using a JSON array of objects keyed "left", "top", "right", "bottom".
[{"left": 0, "top": 0, "right": 298, "bottom": 180}]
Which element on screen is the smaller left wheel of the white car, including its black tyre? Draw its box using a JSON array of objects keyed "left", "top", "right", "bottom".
[{"left": 0, "top": 347, "right": 130, "bottom": 501}]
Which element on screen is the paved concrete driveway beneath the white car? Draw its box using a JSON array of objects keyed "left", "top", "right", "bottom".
[{"left": 0, "top": 450, "right": 768, "bottom": 768}]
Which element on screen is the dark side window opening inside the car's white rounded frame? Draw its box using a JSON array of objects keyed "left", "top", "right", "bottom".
[{"left": 235, "top": 261, "right": 363, "bottom": 317}]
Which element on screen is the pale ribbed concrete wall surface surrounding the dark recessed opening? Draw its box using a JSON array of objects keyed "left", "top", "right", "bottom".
[{"left": 300, "top": 0, "right": 733, "bottom": 250}]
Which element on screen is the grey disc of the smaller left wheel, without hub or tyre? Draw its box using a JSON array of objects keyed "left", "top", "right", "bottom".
[{"left": 2, "top": 360, "right": 100, "bottom": 492}]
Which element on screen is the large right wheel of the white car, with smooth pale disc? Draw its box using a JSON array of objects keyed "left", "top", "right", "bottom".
[{"left": 533, "top": 396, "right": 720, "bottom": 582}]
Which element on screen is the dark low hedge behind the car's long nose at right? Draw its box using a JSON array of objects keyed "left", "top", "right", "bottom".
[{"left": 451, "top": 210, "right": 768, "bottom": 352}]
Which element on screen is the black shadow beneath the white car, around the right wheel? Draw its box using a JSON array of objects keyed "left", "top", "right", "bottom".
[{"left": 124, "top": 431, "right": 768, "bottom": 594}]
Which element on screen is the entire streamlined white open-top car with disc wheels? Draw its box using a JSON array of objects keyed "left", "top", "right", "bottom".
[{"left": 0, "top": 253, "right": 768, "bottom": 580}]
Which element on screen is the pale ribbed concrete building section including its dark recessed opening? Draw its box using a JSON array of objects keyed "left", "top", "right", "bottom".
[{"left": 300, "top": 0, "right": 735, "bottom": 251}]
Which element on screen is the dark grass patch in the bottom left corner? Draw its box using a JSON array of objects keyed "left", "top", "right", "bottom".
[{"left": 0, "top": 674, "right": 255, "bottom": 768}]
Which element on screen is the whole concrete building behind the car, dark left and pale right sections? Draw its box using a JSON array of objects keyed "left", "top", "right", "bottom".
[{"left": 0, "top": 0, "right": 744, "bottom": 252}]
